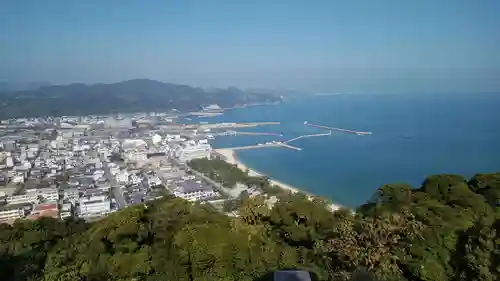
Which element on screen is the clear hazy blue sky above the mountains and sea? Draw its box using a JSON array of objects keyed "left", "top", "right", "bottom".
[{"left": 0, "top": 0, "right": 500, "bottom": 92}]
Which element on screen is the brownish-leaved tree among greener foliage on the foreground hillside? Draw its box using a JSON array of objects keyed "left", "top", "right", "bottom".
[{"left": 316, "top": 210, "right": 422, "bottom": 280}]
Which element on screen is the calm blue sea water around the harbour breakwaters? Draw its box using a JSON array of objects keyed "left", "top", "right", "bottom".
[{"left": 189, "top": 94, "right": 500, "bottom": 207}]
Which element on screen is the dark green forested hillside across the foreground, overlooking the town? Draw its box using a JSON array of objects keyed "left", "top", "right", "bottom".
[{"left": 0, "top": 173, "right": 500, "bottom": 281}]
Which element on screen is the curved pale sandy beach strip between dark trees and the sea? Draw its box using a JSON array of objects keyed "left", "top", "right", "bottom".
[{"left": 214, "top": 148, "right": 344, "bottom": 211}]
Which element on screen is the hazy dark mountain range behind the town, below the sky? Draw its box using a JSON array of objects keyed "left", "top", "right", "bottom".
[{"left": 0, "top": 79, "right": 281, "bottom": 119}]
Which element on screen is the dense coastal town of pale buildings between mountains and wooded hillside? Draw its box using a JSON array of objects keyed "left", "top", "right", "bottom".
[{"left": 0, "top": 109, "right": 282, "bottom": 223}]
